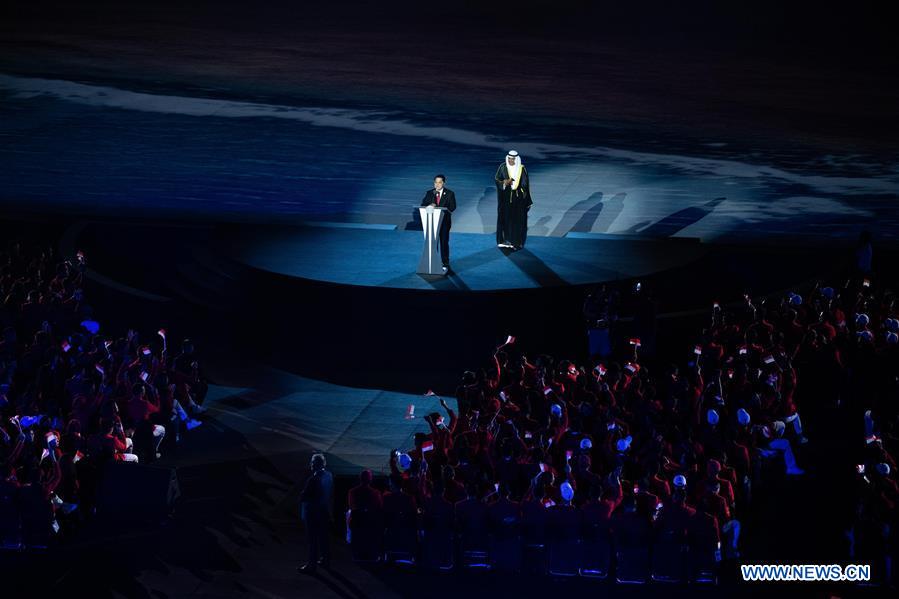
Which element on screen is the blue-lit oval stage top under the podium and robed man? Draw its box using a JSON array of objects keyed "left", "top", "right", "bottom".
[{"left": 224, "top": 224, "right": 709, "bottom": 291}]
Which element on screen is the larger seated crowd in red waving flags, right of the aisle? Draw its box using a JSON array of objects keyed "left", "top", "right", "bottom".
[{"left": 347, "top": 278, "right": 899, "bottom": 580}]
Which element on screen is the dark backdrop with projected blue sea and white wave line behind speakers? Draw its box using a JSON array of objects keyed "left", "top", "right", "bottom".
[{"left": 0, "top": 0, "right": 899, "bottom": 243}]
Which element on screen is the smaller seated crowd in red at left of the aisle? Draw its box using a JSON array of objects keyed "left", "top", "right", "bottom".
[{"left": 0, "top": 243, "right": 206, "bottom": 548}]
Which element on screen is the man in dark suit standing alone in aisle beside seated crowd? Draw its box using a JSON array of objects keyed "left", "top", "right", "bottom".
[{"left": 297, "top": 453, "right": 334, "bottom": 574}]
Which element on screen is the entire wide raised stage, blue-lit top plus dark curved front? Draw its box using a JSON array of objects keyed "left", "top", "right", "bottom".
[{"left": 62, "top": 221, "right": 841, "bottom": 394}]
